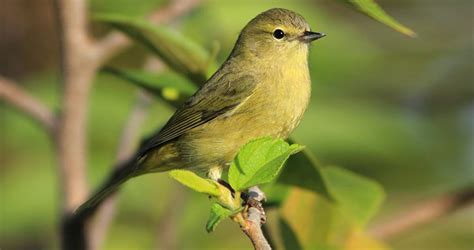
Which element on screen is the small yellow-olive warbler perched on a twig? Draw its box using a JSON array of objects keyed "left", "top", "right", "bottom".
[{"left": 79, "top": 8, "right": 325, "bottom": 213}]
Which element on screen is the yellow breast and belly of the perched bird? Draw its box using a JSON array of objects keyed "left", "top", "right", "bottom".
[{"left": 177, "top": 57, "right": 311, "bottom": 170}]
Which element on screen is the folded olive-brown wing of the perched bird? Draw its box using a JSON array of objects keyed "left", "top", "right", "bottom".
[{"left": 139, "top": 74, "right": 256, "bottom": 156}]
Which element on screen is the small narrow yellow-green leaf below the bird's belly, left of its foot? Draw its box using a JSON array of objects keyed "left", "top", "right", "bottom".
[{"left": 170, "top": 169, "right": 220, "bottom": 196}]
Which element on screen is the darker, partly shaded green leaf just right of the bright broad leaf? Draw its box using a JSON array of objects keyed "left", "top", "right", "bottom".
[{"left": 278, "top": 138, "right": 385, "bottom": 226}]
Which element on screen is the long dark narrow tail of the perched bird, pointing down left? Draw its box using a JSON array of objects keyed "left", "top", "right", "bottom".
[{"left": 74, "top": 159, "right": 138, "bottom": 217}]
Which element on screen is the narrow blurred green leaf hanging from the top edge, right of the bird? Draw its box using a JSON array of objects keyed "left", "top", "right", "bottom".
[{"left": 344, "top": 0, "right": 416, "bottom": 37}]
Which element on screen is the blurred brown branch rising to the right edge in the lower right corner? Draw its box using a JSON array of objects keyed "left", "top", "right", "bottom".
[{"left": 371, "top": 187, "right": 474, "bottom": 240}]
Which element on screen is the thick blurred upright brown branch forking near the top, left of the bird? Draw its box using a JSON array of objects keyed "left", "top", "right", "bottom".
[{"left": 49, "top": 0, "right": 198, "bottom": 249}]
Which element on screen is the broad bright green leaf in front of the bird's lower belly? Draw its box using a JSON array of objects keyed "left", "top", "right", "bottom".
[{"left": 228, "top": 137, "right": 303, "bottom": 191}]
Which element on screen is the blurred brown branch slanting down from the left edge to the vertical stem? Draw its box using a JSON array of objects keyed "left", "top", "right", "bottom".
[{"left": 0, "top": 76, "right": 56, "bottom": 135}]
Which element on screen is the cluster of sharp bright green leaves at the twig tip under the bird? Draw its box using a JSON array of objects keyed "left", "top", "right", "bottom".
[{"left": 170, "top": 137, "right": 308, "bottom": 232}]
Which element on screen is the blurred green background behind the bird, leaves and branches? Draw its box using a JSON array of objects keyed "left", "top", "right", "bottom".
[{"left": 0, "top": 0, "right": 474, "bottom": 250}]
